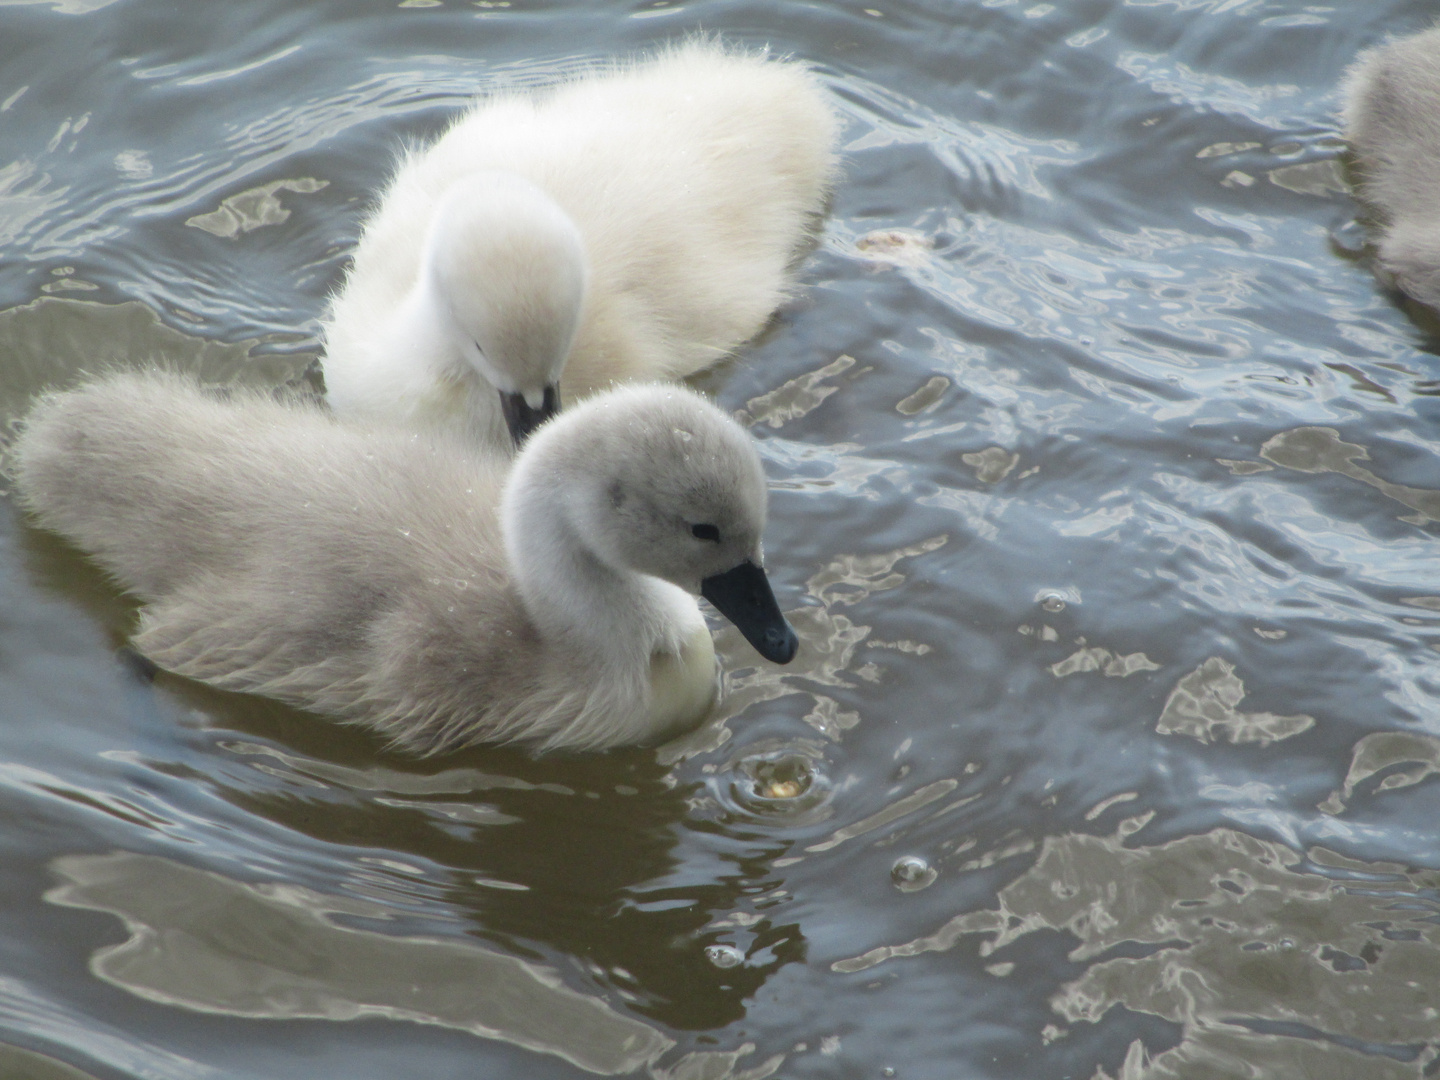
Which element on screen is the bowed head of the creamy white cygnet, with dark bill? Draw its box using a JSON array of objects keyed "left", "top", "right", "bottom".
[{"left": 422, "top": 173, "right": 588, "bottom": 445}]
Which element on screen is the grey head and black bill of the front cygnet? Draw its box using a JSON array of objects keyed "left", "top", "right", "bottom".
[{"left": 503, "top": 384, "right": 798, "bottom": 664}]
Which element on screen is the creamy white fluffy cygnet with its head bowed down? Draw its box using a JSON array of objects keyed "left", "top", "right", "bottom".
[{"left": 324, "top": 40, "right": 837, "bottom": 449}]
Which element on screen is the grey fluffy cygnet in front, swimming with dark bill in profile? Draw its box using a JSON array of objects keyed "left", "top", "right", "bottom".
[{"left": 13, "top": 373, "right": 796, "bottom": 753}]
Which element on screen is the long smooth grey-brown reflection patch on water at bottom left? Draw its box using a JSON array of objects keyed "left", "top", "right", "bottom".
[{"left": 46, "top": 852, "right": 671, "bottom": 1076}]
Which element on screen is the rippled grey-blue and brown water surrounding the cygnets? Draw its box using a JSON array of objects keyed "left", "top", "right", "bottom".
[{"left": 0, "top": 0, "right": 1440, "bottom": 1080}]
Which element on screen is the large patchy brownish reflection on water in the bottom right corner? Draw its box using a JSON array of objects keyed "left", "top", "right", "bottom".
[{"left": 831, "top": 815, "right": 1440, "bottom": 1080}]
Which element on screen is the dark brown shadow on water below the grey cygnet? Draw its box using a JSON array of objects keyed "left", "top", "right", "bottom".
[{"left": 158, "top": 685, "right": 805, "bottom": 1030}]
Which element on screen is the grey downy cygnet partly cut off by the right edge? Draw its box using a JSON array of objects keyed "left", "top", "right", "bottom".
[{"left": 1344, "top": 26, "right": 1440, "bottom": 308}]
